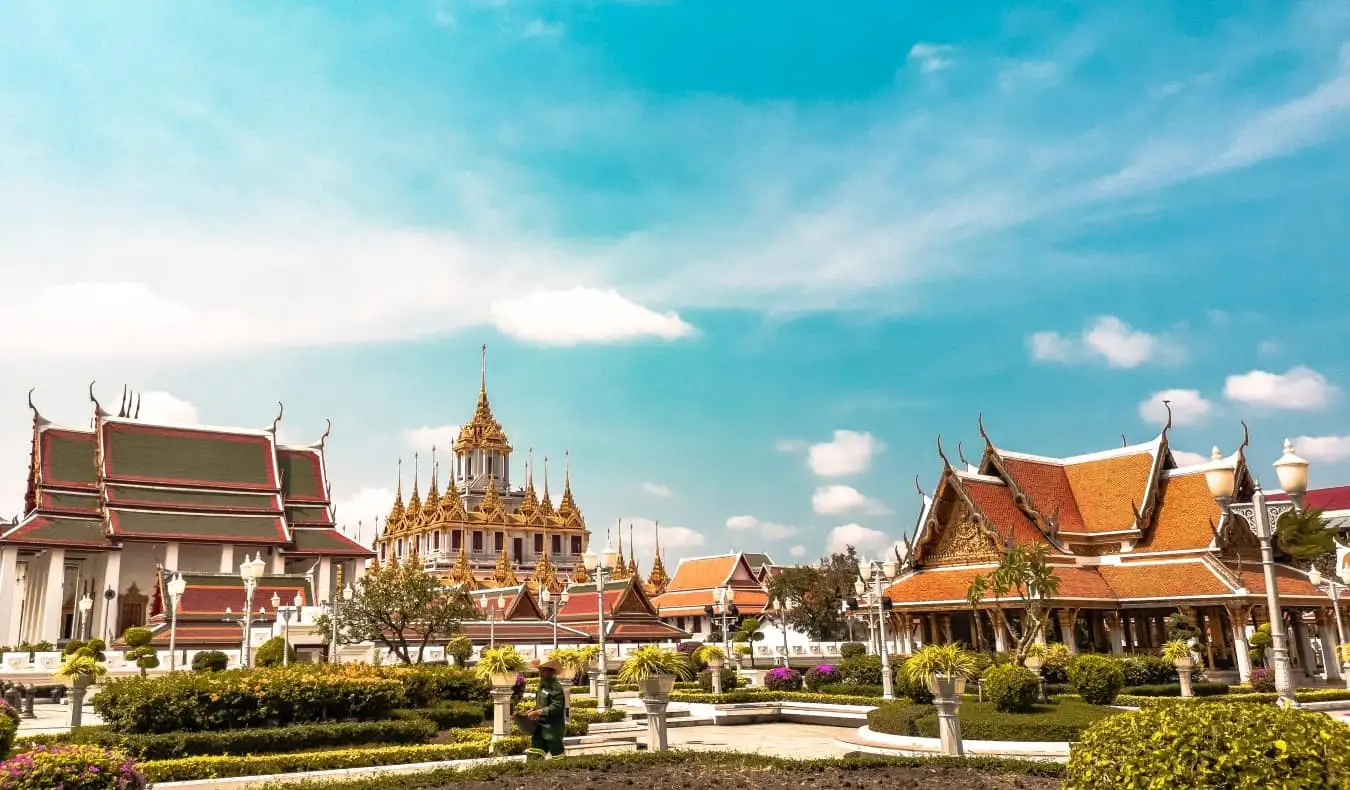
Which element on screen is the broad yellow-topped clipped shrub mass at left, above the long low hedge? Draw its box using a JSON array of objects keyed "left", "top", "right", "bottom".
[{"left": 92, "top": 664, "right": 406, "bottom": 733}]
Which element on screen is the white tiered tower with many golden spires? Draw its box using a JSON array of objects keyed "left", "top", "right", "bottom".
[{"left": 377, "top": 346, "right": 590, "bottom": 593}]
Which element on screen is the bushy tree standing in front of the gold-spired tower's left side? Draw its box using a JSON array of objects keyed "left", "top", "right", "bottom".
[{"left": 315, "top": 562, "right": 478, "bottom": 664}]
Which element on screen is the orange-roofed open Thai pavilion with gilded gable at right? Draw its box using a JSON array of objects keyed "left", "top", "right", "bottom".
[{"left": 887, "top": 421, "right": 1338, "bottom": 681}]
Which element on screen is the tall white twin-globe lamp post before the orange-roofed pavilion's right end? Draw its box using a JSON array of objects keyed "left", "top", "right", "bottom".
[{"left": 1204, "top": 439, "right": 1308, "bottom": 708}]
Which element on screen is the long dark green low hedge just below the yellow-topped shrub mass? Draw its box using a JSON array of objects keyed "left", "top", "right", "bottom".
[{"left": 15, "top": 718, "right": 437, "bottom": 760}]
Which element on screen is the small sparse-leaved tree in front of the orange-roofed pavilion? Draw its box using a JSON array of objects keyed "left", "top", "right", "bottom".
[{"left": 965, "top": 543, "right": 1060, "bottom": 666}]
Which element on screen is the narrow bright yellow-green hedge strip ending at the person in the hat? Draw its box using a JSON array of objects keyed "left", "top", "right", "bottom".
[{"left": 139, "top": 735, "right": 529, "bottom": 783}]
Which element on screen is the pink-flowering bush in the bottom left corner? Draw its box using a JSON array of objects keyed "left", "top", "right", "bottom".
[{"left": 0, "top": 745, "right": 149, "bottom": 790}]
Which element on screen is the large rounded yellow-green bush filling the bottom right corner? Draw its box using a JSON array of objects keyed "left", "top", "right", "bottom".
[{"left": 1064, "top": 702, "right": 1350, "bottom": 790}]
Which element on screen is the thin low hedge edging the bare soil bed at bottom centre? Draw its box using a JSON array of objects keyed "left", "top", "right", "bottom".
[{"left": 248, "top": 751, "right": 1064, "bottom": 790}]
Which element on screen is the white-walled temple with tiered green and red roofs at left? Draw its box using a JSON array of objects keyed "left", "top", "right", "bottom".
[{"left": 0, "top": 385, "right": 373, "bottom": 647}]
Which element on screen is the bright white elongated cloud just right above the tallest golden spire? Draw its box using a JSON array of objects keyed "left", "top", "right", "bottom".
[{"left": 491, "top": 288, "right": 694, "bottom": 346}]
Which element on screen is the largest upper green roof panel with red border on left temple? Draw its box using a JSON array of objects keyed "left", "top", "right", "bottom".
[{"left": 103, "top": 423, "right": 277, "bottom": 489}]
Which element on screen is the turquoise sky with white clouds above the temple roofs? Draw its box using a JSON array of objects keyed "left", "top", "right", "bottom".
[{"left": 0, "top": 0, "right": 1350, "bottom": 560}]
